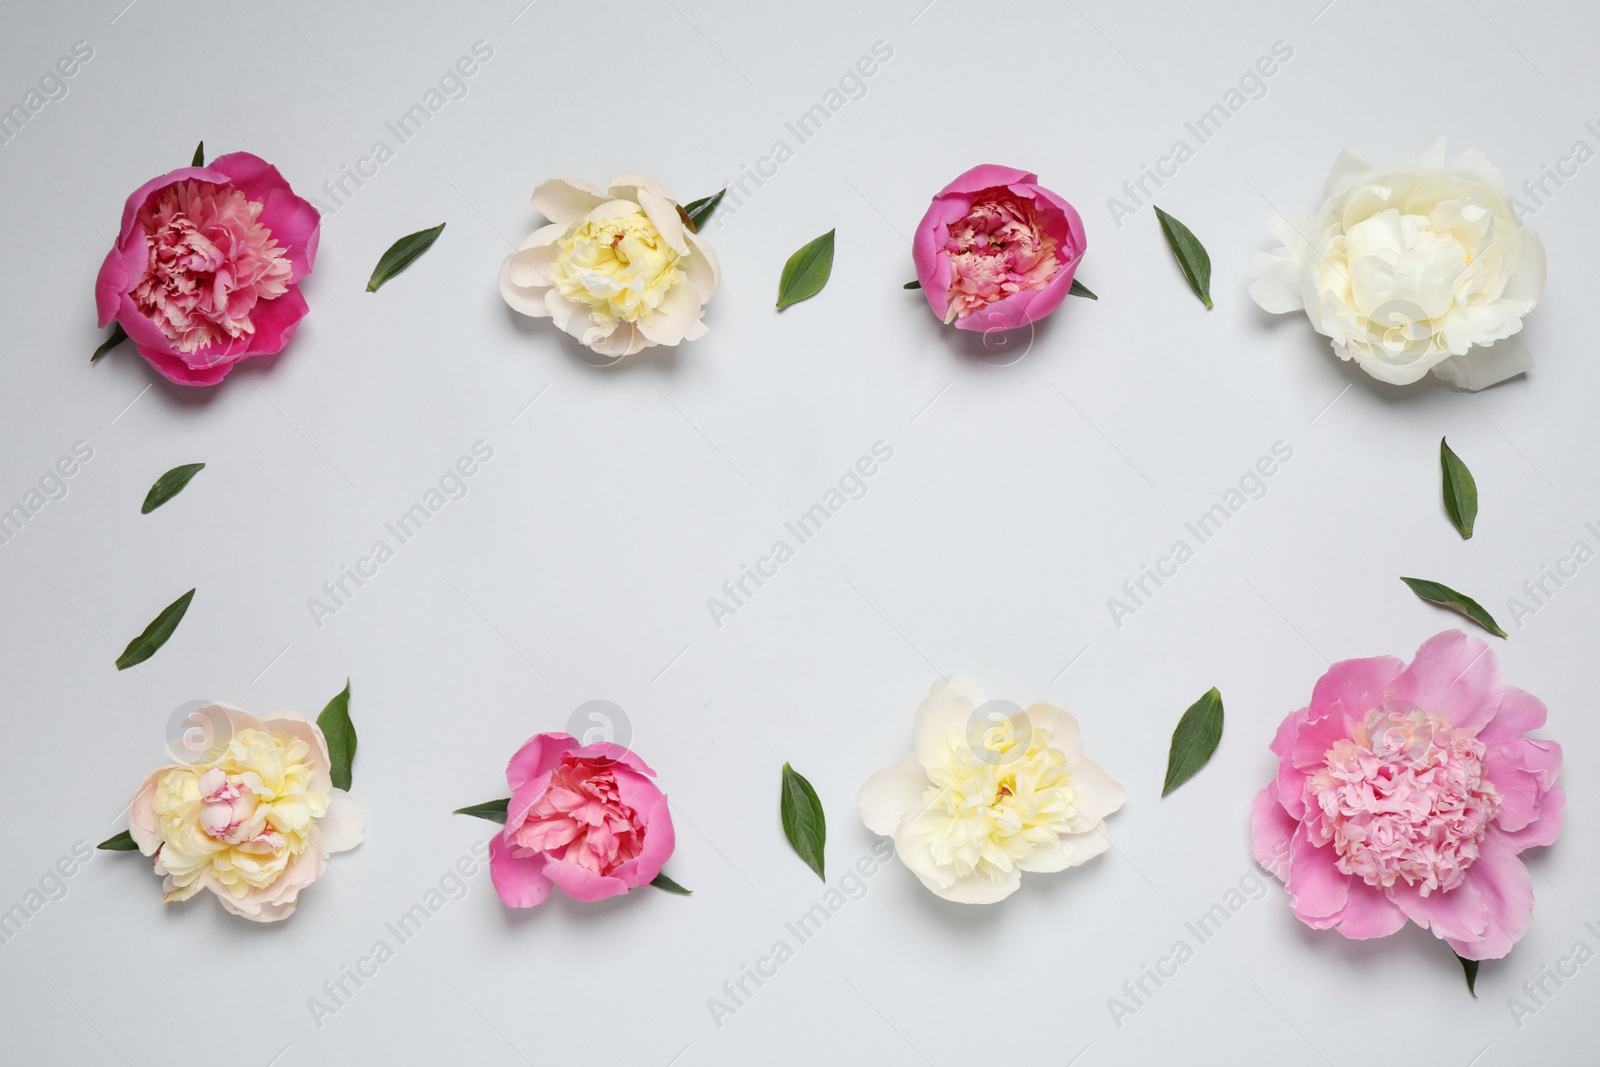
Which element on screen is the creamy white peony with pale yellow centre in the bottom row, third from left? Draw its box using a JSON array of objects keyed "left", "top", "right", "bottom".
[{"left": 859, "top": 675, "right": 1128, "bottom": 904}]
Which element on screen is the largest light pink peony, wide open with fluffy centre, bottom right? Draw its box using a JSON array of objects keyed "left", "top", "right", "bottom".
[{"left": 1251, "top": 630, "right": 1566, "bottom": 960}]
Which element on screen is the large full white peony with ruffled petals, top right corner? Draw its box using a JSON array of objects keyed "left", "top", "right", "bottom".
[{"left": 1250, "top": 136, "right": 1544, "bottom": 389}]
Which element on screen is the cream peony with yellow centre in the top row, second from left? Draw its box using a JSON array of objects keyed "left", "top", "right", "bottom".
[{"left": 501, "top": 173, "right": 720, "bottom": 358}]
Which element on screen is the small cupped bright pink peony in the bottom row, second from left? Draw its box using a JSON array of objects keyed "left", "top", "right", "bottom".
[{"left": 490, "top": 734, "right": 677, "bottom": 907}]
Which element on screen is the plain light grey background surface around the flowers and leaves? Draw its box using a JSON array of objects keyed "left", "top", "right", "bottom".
[{"left": 0, "top": 0, "right": 1600, "bottom": 1067}]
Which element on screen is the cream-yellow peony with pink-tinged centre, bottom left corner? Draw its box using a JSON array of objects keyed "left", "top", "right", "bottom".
[{"left": 128, "top": 704, "right": 366, "bottom": 923}]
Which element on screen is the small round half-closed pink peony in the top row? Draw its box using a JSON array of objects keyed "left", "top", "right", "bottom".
[{"left": 912, "top": 165, "right": 1088, "bottom": 331}]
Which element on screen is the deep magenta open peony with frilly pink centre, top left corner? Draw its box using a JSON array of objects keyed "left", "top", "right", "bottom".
[{"left": 94, "top": 152, "right": 322, "bottom": 386}]
